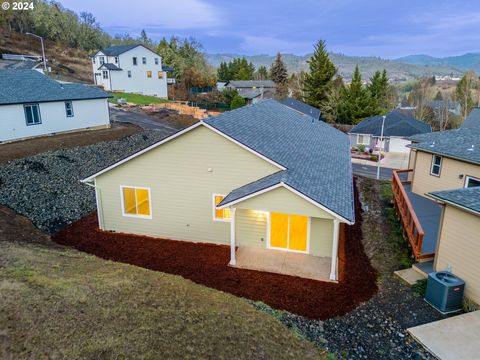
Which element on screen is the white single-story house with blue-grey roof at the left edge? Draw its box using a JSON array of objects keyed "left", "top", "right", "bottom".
[{"left": 0, "top": 69, "right": 110, "bottom": 142}]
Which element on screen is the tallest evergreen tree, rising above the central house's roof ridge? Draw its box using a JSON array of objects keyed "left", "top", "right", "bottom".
[{"left": 302, "top": 40, "right": 337, "bottom": 109}]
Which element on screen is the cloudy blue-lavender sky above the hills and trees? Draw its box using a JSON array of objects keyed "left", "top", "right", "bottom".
[{"left": 60, "top": 0, "right": 480, "bottom": 58}]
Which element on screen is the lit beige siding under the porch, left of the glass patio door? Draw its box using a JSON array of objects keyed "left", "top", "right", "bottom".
[{"left": 235, "top": 209, "right": 268, "bottom": 248}]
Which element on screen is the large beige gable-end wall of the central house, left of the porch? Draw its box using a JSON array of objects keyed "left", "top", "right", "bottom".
[{"left": 96, "top": 126, "right": 280, "bottom": 244}]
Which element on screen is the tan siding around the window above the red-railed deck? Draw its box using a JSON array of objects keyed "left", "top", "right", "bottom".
[{"left": 412, "top": 151, "right": 480, "bottom": 195}]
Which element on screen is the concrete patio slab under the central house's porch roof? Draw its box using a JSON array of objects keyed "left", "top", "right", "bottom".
[{"left": 235, "top": 247, "right": 331, "bottom": 281}]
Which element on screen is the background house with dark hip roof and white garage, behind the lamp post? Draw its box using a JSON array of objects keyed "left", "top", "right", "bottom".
[{"left": 348, "top": 110, "right": 432, "bottom": 153}]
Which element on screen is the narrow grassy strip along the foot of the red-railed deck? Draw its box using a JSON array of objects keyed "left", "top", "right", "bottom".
[{"left": 381, "top": 183, "right": 414, "bottom": 268}]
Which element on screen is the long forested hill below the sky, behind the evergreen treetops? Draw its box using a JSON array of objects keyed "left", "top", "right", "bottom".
[{"left": 206, "top": 53, "right": 463, "bottom": 81}]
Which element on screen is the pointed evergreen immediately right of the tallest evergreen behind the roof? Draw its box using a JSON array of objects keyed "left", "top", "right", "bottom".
[{"left": 338, "top": 65, "right": 380, "bottom": 124}]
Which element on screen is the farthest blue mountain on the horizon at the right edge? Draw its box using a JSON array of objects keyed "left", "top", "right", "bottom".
[{"left": 395, "top": 53, "right": 480, "bottom": 73}]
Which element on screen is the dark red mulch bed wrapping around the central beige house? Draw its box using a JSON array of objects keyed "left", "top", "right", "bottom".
[{"left": 53, "top": 179, "right": 377, "bottom": 319}]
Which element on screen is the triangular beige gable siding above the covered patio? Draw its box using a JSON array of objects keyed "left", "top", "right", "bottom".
[{"left": 233, "top": 187, "right": 333, "bottom": 219}]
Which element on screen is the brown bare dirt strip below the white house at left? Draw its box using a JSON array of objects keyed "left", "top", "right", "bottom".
[{"left": 0, "top": 123, "right": 143, "bottom": 165}]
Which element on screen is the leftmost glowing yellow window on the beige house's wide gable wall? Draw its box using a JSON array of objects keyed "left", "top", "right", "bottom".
[{"left": 120, "top": 186, "right": 152, "bottom": 219}]
